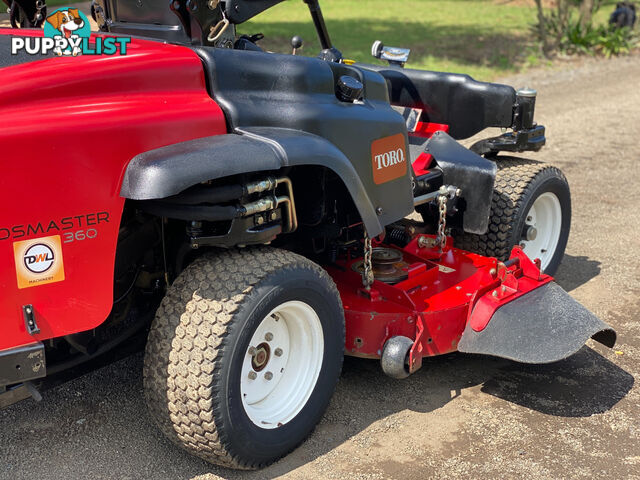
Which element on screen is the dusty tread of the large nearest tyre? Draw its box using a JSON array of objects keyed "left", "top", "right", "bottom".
[{"left": 143, "top": 247, "right": 339, "bottom": 469}]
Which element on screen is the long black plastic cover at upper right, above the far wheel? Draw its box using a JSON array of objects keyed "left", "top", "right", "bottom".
[{"left": 358, "top": 64, "right": 516, "bottom": 139}]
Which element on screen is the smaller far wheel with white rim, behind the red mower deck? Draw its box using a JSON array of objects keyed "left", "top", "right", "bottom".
[{"left": 455, "top": 157, "right": 571, "bottom": 275}]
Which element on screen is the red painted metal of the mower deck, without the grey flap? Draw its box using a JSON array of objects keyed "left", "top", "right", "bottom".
[{"left": 326, "top": 237, "right": 552, "bottom": 364}]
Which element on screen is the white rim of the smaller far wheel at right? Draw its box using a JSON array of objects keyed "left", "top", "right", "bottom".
[{"left": 521, "top": 192, "right": 562, "bottom": 271}]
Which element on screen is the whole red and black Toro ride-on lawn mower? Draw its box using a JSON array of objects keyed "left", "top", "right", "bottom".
[{"left": 0, "top": 0, "right": 615, "bottom": 468}]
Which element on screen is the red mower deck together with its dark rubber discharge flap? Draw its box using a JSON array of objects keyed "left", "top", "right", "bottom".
[{"left": 327, "top": 235, "right": 615, "bottom": 372}]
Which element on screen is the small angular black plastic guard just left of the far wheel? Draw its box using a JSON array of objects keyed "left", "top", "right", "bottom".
[{"left": 424, "top": 132, "right": 497, "bottom": 235}]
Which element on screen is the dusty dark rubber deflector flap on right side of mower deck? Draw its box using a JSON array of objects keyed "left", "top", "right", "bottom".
[{"left": 458, "top": 282, "right": 616, "bottom": 363}]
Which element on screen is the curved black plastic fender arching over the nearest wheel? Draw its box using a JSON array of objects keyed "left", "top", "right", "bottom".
[{"left": 120, "top": 127, "right": 383, "bottom": 237}]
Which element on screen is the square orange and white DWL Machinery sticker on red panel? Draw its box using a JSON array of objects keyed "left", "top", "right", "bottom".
[{"left": 13, "top": 235, "right": 64, "bottom": 288}]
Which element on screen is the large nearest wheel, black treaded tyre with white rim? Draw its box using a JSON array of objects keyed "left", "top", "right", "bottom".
[{"left": 144, "top": 248, "right": 344, "bottom": 469}]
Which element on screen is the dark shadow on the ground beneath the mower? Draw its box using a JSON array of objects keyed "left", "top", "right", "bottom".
[{"left": 0, "top": 347, "right": 633, "bottom": 480}]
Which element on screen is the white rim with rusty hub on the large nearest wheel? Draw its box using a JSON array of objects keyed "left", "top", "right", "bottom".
[{"left": 240, "top": 300, "right": 324, "bottom": 429}]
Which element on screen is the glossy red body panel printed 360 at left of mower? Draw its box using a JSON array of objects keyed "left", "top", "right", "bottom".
[{"left": 0, "top": 29, "right": 226, "bottom": 350}]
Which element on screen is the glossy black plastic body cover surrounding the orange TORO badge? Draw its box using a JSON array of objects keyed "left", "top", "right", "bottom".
[{"left": 195, "top": 47, "right": 413, "bottom": 235}]
